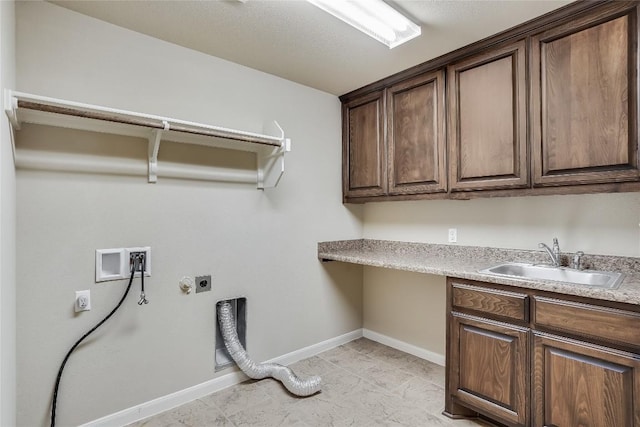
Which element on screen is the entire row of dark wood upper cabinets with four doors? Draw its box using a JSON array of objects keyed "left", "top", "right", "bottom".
[{"left": 340, "top": 1, "right": 640, "bottom": 203}]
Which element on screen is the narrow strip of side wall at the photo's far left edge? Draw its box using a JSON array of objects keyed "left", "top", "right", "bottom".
[{"left": 0, "top": 1, "right": 16, "bottom": 426}]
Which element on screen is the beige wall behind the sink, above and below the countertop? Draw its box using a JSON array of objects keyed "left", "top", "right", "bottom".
[{"left": 363, "top": 193, "right": 640, "bottom": 357}]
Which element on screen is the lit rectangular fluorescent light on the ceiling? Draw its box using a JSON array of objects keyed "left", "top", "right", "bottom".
[{"left": 307, "top": 0, "right": 421, "bottom": 49}]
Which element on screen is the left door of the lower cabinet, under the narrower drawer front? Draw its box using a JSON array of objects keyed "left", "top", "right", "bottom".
[{"left": 445, "top": 313, "right": 529, "bottom": 426}]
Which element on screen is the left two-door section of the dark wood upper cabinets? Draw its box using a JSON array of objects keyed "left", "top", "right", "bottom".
[{"left": 343, "top": 71, "right": 447, "bottom": 200}]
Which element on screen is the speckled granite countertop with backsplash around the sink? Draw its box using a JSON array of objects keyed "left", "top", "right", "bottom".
[{"left": 318, "top": 239, "right": 640, "bottom": 305}]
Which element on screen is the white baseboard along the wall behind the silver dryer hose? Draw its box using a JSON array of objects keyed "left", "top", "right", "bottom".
[{"left": 81, "top": 329, "right": 362, "bottom": 427}]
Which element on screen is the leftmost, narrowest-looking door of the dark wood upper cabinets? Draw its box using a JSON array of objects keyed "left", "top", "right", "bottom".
[{"left": 342, "top": 91, "right": 387, "bottom": 197}]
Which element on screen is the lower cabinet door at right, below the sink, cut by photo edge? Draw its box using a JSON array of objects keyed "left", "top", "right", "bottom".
[{"left": 533, "top": 333, "right": 640, "bottom": 427}]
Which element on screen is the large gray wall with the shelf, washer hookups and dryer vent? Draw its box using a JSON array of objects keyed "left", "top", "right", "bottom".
[{"left": 16, "top": 2, "right": 362, "bottom": 426}]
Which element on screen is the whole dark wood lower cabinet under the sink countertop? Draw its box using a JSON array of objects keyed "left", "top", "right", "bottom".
[{"left": 444, "top": 278, "right": 640, "bottom": 427}]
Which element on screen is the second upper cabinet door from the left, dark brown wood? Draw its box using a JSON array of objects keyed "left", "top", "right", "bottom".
[{"left": 387, "top": 71, "right": 447, "bottom": 194}]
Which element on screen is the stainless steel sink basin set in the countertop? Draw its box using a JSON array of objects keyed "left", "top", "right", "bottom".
[{"left": 479, "top": 262, "right": 624, "bottom": 289}]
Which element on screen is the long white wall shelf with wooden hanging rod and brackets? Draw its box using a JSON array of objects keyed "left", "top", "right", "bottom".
[{"left": 4, "top": 89, "right": 291, "bottom": 189}]
